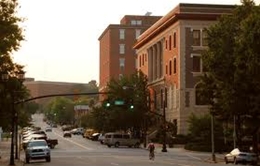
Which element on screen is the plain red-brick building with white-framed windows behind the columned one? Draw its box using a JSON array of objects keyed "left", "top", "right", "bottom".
[{"left": 98, "top": 14, "right": 161, "bottom": 97}]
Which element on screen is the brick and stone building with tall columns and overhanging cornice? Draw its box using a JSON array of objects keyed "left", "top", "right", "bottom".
[{"left": 133, "top": 3, "right": 235, "bottom": 134}]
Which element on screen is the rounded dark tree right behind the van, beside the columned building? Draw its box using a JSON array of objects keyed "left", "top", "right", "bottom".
[{"left": 97, "top": 72, "right": 149, "bottom": 136}]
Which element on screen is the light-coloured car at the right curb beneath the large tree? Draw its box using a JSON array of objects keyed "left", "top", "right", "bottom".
[{"left": 224, "top": 148, "right": 258, "bottom": 165}]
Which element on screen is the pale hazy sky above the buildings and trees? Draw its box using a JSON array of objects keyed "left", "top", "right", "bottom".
[{"left": 13, "top": 0, "right": 252, "bottom": 83}]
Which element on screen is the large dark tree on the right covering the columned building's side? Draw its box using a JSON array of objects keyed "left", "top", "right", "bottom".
[{"left": 201, "top": 0, "right": 260, "bottom": 150}]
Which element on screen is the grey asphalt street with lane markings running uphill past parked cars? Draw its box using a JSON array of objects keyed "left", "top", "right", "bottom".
[{"left": 18, "top": 115, "right": 230, "bottom": 166}]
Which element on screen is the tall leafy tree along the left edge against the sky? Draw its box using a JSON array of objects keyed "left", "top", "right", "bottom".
[{"left": 0, "top": 0, "right": 27, "bottom": 129}]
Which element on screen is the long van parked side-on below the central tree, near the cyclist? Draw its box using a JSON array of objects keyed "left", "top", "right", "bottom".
[{"left": 104, "top": 133, "right": 140, "bottom": 148}]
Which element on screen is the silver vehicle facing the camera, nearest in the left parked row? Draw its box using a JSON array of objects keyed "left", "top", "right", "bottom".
[{"left": 25, "top": 139, "right": 51, "bottom": 163}]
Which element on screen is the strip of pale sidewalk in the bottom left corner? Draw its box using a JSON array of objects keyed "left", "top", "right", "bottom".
[{"left": 0, "top": 140, "right": 24, "bottom": 166}]
